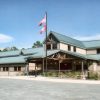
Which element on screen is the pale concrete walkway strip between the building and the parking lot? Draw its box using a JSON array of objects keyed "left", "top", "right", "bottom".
[{"left": 0, "top": 76, "right": 100, "bottom": 84}]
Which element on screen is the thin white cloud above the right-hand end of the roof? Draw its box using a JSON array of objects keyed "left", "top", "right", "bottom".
[{"left": 74, "top": 34, "right": 100, "bottom": 41}]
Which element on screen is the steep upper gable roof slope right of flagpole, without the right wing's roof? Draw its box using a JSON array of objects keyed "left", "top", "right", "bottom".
[{"left": 49, "top": 31, "right": 85, "bottom": 48}]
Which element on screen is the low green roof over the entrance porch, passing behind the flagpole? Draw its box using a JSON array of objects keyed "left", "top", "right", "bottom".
[{"left": 23, "top": 47, "right": 100, "bottom": 61}]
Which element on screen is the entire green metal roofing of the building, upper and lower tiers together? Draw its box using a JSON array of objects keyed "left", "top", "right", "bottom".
[{"left": 0, "top": 31, "right": 100, "bottom": 64}]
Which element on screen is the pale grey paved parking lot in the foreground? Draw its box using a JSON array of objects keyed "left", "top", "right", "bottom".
[{"left": 0, "top": 79, "right": 100, "bottom": 100}]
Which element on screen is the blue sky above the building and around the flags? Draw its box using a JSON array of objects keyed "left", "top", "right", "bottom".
[{"left": 0, "top": 0, "right": 100, "bottom": 48}]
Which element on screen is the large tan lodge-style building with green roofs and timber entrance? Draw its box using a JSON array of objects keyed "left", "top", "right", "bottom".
[{"left": 0, "top": 31, "right": 100, "bottom": 75}]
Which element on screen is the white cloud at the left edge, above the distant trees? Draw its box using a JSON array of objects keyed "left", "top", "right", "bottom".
[{"left": 0, "top": 33, "right": 14, "bottom": 43}]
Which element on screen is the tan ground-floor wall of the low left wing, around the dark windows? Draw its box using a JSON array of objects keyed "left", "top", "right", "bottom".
[{"left": 0, "top": 63, "right": 42, "bottom": 76}]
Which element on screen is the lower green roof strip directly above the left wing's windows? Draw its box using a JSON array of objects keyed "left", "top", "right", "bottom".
[{"left": 0, "top": 56, "right": 26, "bottom": 64}]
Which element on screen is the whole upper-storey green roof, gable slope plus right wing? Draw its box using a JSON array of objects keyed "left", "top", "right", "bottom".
[{"left": 48, "top": 31, "right": 100, "bottom": 49}]
